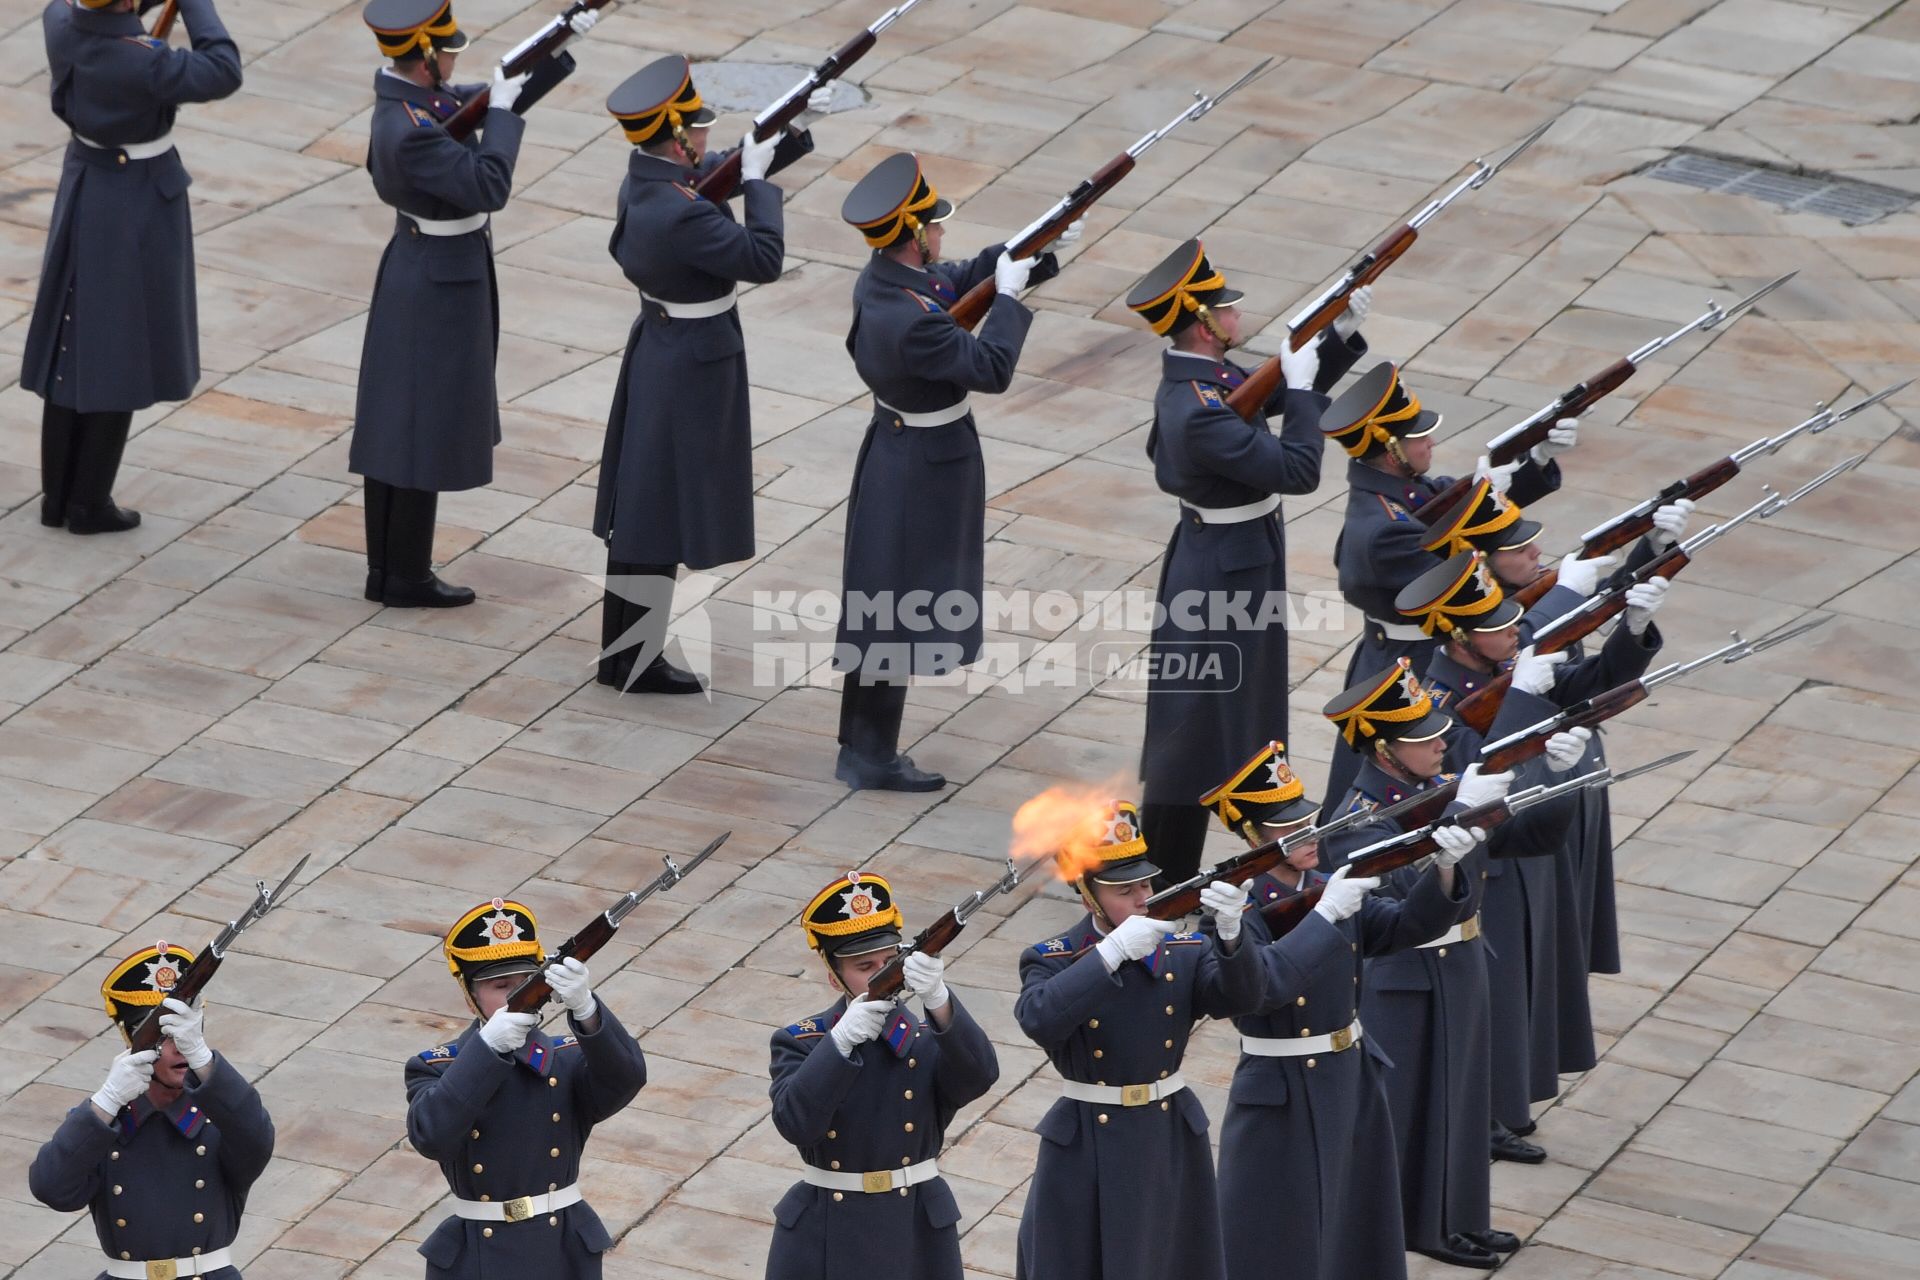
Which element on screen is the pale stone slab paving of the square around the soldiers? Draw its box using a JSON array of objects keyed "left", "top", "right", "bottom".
[{"left": 0, "top": 0, "right": 1920, "bottom": 1280}]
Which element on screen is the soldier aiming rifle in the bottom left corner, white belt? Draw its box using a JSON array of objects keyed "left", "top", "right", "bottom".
[{"left": 27, "top": 942, "right": 273, "bottom": 1280}]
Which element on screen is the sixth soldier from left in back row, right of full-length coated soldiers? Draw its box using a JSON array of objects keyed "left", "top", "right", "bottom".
[{"left": 1321, "top": 361, "right": 1580, "bottom": 812}]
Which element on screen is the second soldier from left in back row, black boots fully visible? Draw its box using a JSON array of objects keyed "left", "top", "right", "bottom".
[{"left": 348, "top": 0, "right": 597, "bottom": 608}]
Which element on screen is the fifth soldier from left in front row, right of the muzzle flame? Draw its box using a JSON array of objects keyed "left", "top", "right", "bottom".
[{"left": 1212, "top": 694, "right": 1492, "bottom": 1280}]
